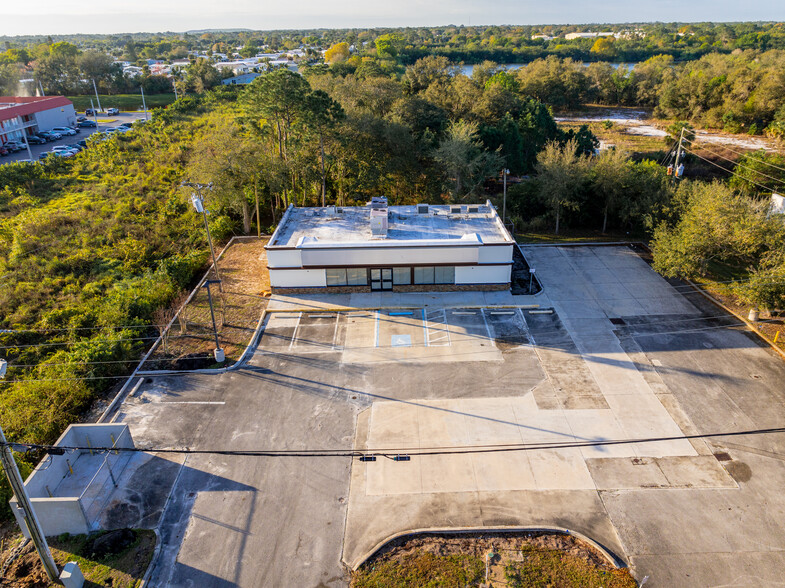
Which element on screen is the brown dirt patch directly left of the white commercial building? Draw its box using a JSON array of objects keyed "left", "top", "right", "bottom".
[{"left": 145, "top": 237, "right": 270, "bottom": 369}]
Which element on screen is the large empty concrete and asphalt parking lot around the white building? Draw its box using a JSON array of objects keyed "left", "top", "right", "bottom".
[{"left": 107, "top": 246, "right": 785, "bottom": 587}]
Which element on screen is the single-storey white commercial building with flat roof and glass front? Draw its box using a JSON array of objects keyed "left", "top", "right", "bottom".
[{"left": 266, "top": 198, "right": 514, "bottom": 293}]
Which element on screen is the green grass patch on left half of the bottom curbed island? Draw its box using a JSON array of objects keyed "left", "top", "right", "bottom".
[{"left": 351, "top": 550, "right": 485, "bottom": 588}]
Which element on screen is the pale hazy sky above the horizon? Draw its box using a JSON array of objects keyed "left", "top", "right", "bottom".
[{"left": 0, "top": 0, "right": 785, "bottom": 36}]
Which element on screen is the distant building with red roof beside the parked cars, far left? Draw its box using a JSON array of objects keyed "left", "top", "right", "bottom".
[{"left": 0, "top": 96, "right": 76, "bottom": 143}]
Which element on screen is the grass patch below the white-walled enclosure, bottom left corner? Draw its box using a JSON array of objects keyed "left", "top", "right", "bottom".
[{"left": 49, "top": 529, "right": 156, "bottom": 588}]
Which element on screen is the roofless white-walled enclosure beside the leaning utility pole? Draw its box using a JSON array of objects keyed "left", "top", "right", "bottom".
[{"left": 10, "top": 424, "right": 134, "bottom": 537}]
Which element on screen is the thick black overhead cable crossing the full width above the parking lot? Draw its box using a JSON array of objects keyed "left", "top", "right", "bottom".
[{"left": 6, "top": 427, "right": 785, "bottom": 457}]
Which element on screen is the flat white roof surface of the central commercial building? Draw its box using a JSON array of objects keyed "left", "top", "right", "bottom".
[{"left": 268, "top": 203, "right": 513, "bottom": 248}]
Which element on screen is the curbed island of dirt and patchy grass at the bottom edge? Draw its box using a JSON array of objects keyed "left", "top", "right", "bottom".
[{"left": 351, "top": 532, "right": 637, "bottom": 588}]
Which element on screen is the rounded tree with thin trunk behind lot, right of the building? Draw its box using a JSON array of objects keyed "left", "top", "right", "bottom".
[{"left": 535, "top": 140, "right": 589, "bottom": 235}]
